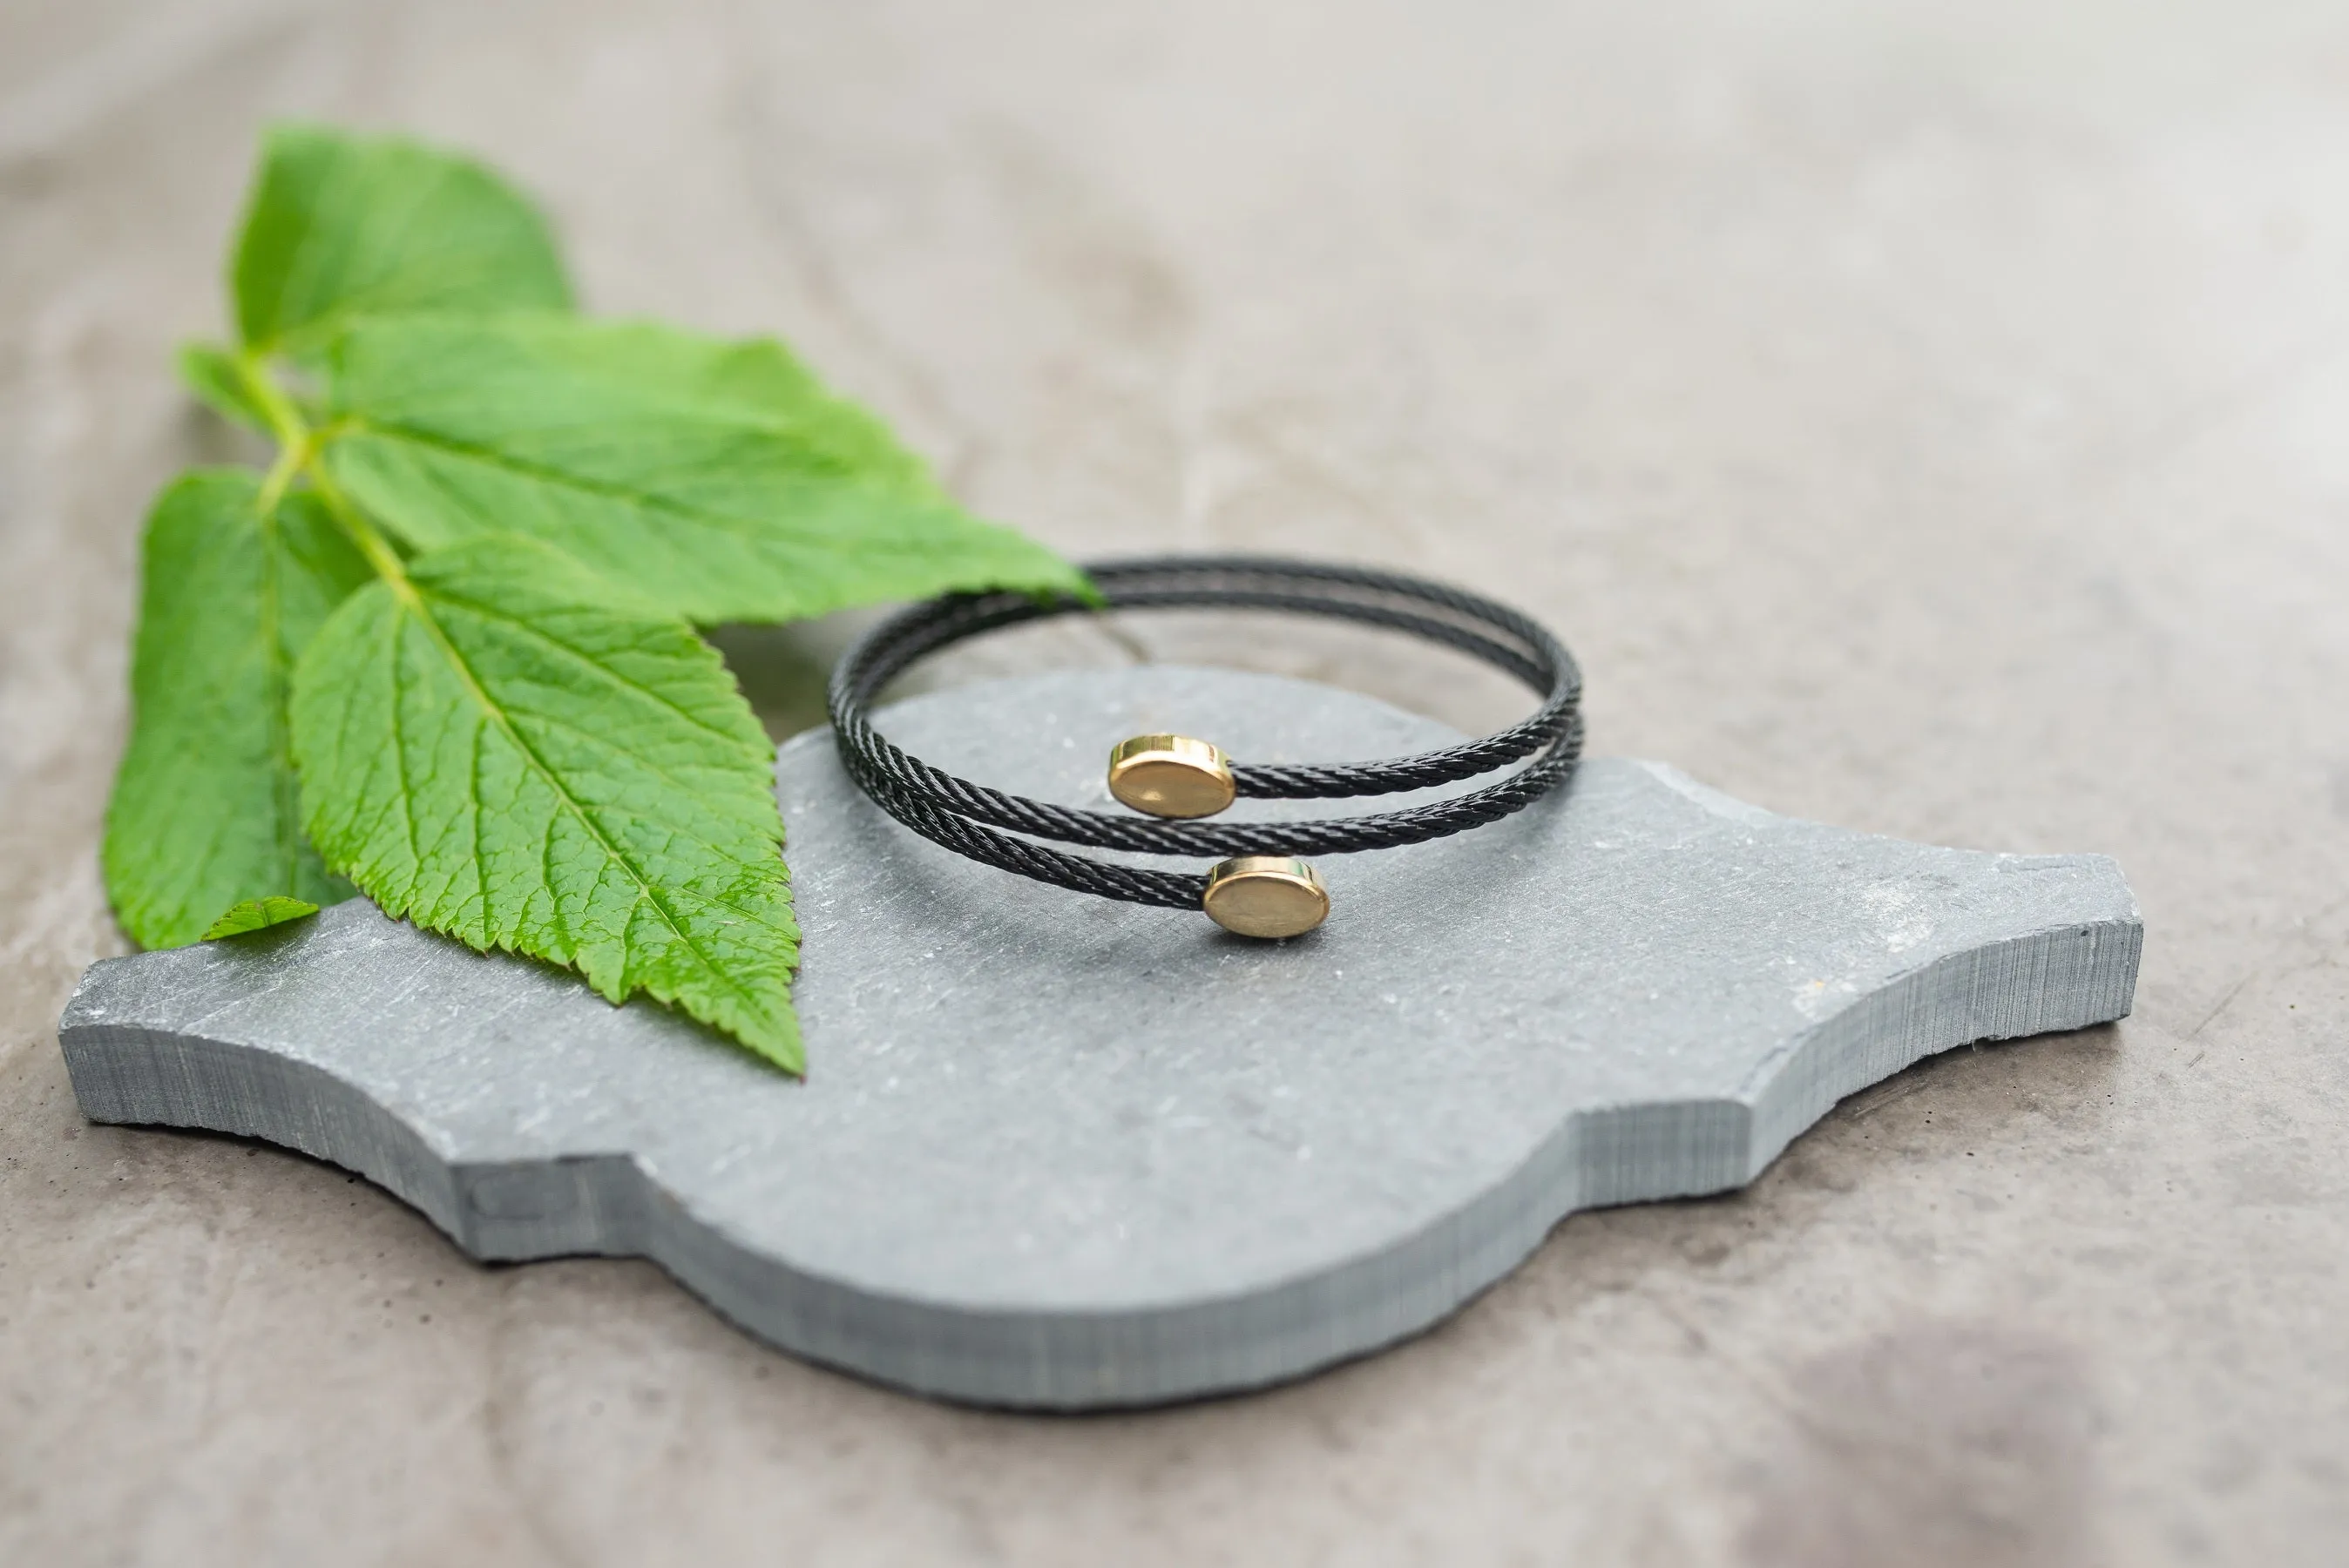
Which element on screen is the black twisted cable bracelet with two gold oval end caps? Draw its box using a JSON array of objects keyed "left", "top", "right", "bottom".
[{"left": 827, "top": 557, "right": 1583, "bottom": 936}]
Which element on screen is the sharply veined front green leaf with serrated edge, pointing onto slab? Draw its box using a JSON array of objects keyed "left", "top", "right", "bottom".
[{"left": 294, "top": 537, "right": 801, "bottom": 1072}]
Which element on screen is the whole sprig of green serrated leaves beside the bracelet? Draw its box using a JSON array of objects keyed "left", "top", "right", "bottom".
[{"left": 104, "top": 127, "right": 1093, "bottom": 1072}]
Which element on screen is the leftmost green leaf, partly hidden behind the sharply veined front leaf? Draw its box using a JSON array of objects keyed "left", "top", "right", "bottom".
[{"left": 101, "top": 470, "right": 369, "bottom": 949}]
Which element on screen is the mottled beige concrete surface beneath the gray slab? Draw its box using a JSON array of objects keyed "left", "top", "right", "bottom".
[{"left": 0, "top": 0, "right": 2349, "bottom": 1568}]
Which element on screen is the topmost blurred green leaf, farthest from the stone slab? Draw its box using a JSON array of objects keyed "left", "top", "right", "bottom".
[{"left": 230, "top": 125, "right": 571, "bottom": 357}]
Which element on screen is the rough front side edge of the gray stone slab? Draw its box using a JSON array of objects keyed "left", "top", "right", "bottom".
[{"left": 58, "top": 891, "right": 2144, "bottom": 1409}]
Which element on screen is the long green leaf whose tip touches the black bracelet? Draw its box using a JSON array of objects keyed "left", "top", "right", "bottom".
[{"left": 308, "top": 317, "right": 1087, "bottom": 625}]
